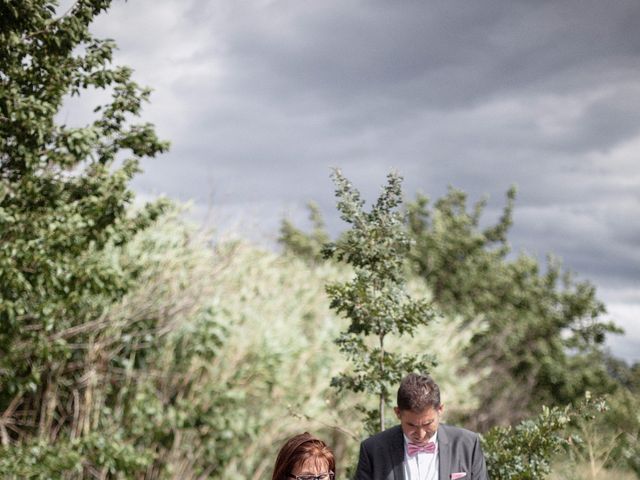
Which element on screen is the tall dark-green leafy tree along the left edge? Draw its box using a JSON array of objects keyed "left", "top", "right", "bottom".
[{"left": 0, "top": 0, "right": 168, "bottom": 476}]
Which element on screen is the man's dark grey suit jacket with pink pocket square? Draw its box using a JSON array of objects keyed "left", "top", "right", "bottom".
[{"left": 356, "top": 424, "right": 489, "bottom": 480}]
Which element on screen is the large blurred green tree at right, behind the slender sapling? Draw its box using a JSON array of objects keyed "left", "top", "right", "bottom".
[{"left": 408, "top": 189, "right": 618, "bottom": 430}]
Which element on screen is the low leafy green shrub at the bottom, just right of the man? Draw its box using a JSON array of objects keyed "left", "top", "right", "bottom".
[{"left": 483, "top": 395, "right": 606, "bottom": 480}]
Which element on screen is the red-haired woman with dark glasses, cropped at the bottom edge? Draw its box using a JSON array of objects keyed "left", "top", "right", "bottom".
[{"left": 271, "top": 432, "right": 336, "bottom": 480}]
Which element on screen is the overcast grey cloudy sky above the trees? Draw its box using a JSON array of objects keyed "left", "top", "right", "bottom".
[{"left": 77, "top": 0, "right": 640, "bottom": 360}]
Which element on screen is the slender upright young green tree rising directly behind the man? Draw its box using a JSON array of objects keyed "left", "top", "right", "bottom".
[{"left": 324, "top": 170, "right": 434, "bottom": 431}]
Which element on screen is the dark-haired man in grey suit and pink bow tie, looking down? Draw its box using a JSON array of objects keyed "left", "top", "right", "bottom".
[{"left": 356, "top": 373, "right": 489, "bottom": 480}]
